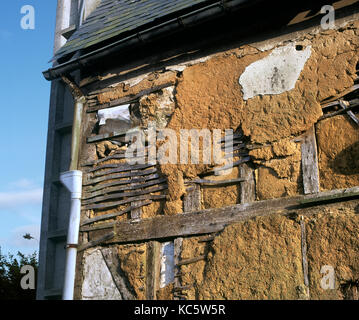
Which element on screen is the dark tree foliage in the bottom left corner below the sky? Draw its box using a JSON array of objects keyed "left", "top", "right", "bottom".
[{"left": 0, "top": 248, "right": 38, "bottom": 300}]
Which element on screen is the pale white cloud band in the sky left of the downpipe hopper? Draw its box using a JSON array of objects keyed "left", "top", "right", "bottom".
[{"left": 0, "top": 188, "right": 43, "bottom": 209}]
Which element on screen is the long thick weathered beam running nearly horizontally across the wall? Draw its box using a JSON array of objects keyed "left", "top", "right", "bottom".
[{"left": 101, "top": 187, "right": 359, "bottom": 243}]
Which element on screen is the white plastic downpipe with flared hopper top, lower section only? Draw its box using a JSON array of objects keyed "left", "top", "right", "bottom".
[{"left": 60, "top": 170, "right": 82, "bottom": 300}]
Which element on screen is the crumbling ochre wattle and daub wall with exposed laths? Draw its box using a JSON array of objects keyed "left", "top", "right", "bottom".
[{"left": 77, "top": 14, "right": 359, "bottom": 299}]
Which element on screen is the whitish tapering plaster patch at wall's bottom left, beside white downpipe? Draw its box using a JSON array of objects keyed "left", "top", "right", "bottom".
[{"left": 82, "top": 250, "right": 122, "bottom": 300}]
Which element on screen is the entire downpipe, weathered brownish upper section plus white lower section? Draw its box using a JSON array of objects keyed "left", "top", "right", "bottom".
[{"left": 60, "top": 96, "right": 85, "bottom": 300}]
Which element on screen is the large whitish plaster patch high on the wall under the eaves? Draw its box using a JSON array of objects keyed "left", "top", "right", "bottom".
[{"left": 239, "top": 44, "right": 311, "bottom": 100}]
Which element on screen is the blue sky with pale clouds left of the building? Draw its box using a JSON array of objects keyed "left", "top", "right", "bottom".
[{"left": 0, "top": 0, "right": 57, "bottom": 254}]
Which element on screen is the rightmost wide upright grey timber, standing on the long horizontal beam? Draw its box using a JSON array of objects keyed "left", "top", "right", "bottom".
[{"left": 301, "top": 126, "right": 319, "bottom": 194}]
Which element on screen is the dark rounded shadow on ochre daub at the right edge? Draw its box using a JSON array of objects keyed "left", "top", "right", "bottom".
[{"left": 331, "top": 141, "right": 359, "bottom": 175}]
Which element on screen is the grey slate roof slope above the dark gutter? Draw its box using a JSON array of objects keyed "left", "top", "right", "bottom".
[{"left": 54, "top": 0, "right": 213, "bottom": 60}]
